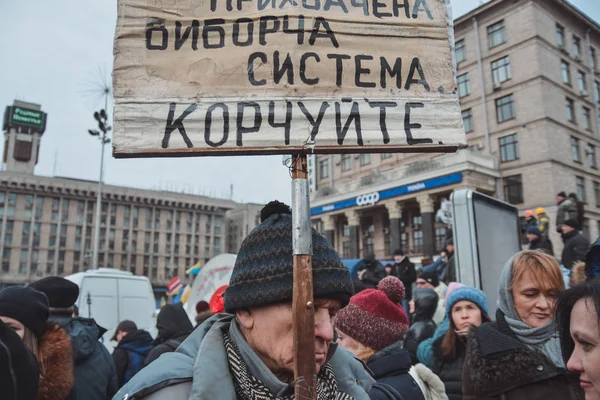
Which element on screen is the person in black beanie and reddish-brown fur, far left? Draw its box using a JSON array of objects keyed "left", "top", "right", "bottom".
[{"left": 0, "top": 286, "right": 74, "bottom": 400}]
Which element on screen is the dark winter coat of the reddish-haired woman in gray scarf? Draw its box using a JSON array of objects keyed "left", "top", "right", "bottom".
[{"left": 462, "top": 313, "right": 584, "bottom": 400}]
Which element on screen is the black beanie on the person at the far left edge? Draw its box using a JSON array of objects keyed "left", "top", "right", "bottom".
[{"left": 0, "top": 286, "right": 49, "bottom": 338}]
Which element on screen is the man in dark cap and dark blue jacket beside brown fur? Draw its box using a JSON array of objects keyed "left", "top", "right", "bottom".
[{"left": 29, "top": 276, "right": 118, "bottom": 400}]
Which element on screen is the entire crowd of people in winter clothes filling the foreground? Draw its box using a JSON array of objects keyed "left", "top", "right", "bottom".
[{"left": 0, "top": 202, "right": 600, "bottom": 400}]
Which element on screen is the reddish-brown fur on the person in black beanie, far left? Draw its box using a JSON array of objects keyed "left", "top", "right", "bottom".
[{"left": 37, "top": 322, "right": 74, "bottom": 400}]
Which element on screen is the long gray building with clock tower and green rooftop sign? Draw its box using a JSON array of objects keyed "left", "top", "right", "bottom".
[{"left": 0, "top": 102, "right": 244, "bottom": 287}]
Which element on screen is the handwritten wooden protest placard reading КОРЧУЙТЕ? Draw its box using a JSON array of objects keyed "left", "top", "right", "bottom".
[{"left": 113, "top": 0, "right": 466, "bottom": 157}]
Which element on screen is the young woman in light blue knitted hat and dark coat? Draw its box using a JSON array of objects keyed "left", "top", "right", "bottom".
[{"left": 432, "top": 286, "right": 490, "bottom": 400}]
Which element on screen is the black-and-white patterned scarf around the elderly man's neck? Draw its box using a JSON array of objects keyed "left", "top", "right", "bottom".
[{"left": 223, "top": 332, "right": 354, "bottom": 400}]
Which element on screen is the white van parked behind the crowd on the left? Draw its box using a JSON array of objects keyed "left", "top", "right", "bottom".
[{"left": 65, "top": 268, "right": 157, "bottom": 351}]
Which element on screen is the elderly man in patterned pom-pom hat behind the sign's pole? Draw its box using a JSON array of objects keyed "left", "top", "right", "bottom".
[{"left": 114, "top": 202, "right": 374, "bottom": 400}]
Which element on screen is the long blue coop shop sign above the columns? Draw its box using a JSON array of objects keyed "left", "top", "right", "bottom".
[{"left": 310, "top": 172, "right": 462, "bottom": 215}]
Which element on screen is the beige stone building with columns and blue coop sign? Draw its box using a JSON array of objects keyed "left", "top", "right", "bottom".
[{"left": 311, "top": 0, "right": 600, "bottom": 258}]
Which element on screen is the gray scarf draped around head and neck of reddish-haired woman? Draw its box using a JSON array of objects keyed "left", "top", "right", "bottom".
[{"left": 498, "top": 255, "right": 565, "bottom": 368}]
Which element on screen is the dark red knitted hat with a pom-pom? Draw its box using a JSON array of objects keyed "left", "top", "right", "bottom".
[{"left": 335, "top": 276, "right": 408, "bottom": 351}]
